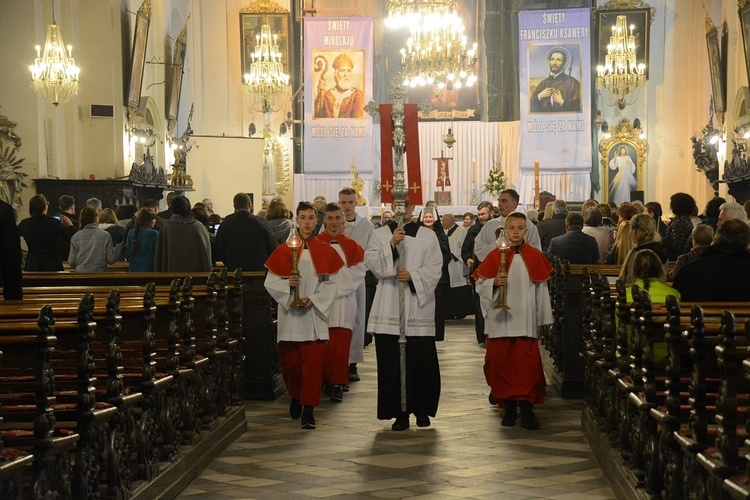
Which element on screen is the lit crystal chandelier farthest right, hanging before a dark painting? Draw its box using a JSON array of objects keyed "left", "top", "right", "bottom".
[{"left": 596, "top": 16, "right": 646, "bottom": 109}]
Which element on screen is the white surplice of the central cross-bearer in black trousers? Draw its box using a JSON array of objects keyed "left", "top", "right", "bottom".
[{"left": 365, "top": 227, "right": 443, "bottom": 337}]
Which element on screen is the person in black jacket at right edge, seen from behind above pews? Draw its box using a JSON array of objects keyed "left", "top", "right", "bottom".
[{"left": 672, "top": 219, "right": 750, "bottom": 302}]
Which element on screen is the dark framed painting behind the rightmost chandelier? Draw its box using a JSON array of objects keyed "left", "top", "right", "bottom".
[{"left": 596, "top": 8, "right": 651, "bottom": 79}]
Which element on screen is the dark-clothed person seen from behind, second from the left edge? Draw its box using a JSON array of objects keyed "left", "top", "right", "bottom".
[{"left": 18, "top": 194, "right": 76, "bottom": 271}]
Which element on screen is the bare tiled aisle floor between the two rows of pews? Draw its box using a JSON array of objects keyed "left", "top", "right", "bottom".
[{"left": 179, "top": 319, "right": 614, "bottom": 500}]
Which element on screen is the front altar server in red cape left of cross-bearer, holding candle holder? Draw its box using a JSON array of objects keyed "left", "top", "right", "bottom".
[{"left": 265, "top": 202, "right": 344, "bottom": 429}]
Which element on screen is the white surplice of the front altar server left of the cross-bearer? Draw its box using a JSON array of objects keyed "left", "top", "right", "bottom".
[{"left": 265, "top": 249, "right": 340, "bottom": 342}]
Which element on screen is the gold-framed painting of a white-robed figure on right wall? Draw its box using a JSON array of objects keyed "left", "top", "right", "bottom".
[{"left": 599, "top": 120, "right": 648, "bottom": 205}]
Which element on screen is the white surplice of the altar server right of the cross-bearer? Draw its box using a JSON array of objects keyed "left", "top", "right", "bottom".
[{"left": 476, "top": 255, "right": 553, "bottom": 339}]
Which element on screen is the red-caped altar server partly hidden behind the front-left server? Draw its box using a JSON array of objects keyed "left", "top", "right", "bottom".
[{"left": 315, "top": 203, "right": 367, "bottom": 403}]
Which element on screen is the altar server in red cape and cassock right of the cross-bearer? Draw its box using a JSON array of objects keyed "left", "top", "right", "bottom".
[{"left": 474, "top": 212, "right": 553, "bottom": 429}]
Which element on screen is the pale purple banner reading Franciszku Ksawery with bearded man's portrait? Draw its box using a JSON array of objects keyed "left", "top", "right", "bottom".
[{"left": 518, "top": 9, "right": 591, "bottom": 174}]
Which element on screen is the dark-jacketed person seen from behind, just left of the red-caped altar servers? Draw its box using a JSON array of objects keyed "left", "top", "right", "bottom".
[{"left": 215, "top": 193, "right": 276, "bottom": 271}]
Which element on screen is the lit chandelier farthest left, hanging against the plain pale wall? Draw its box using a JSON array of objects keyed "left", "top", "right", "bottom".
[{"left": 29, "top": 0, "right": 81, "bottom": 106}]
